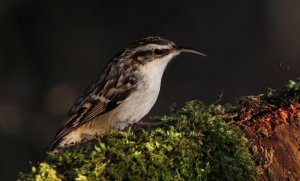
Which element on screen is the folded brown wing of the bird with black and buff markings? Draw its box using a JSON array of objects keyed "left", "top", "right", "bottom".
[{"left": 51, "top": 60, "right": 137, "bottom": 150}]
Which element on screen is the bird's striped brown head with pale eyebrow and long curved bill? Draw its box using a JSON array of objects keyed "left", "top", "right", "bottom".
[{"left": 121, "top": 37, "right": 206, "bottom": 64}]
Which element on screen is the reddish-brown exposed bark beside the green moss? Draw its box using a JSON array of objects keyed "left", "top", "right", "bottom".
[{"left": 236, "top": 102, "right": 300, "bottom": 181}]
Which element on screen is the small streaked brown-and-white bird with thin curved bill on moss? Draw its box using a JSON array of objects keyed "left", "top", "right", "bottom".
[{"left": 50, "top": 36, "right": 205, "bottom": 151}]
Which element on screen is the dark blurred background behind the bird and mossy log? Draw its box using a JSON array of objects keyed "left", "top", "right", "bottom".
[{"left": 0, "top": 0, "right": 300, "bottom": 180}]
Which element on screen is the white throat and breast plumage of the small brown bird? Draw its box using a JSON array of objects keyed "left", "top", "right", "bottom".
[{"left": 117, "top": 54, "right": 174, "bottom": 129}]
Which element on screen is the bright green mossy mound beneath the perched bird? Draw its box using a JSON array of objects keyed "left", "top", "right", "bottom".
[{"left": 19, "top": 101, "right": 256, "bottom": 180}]
